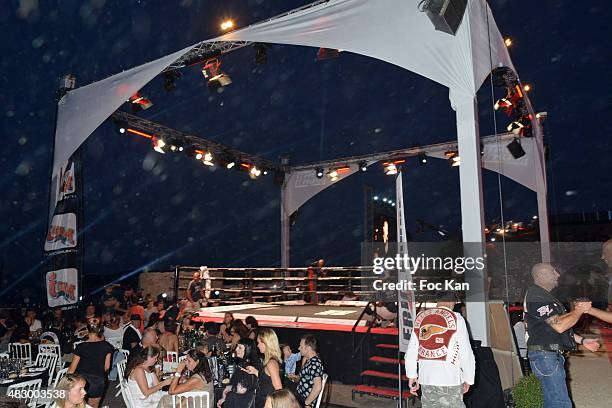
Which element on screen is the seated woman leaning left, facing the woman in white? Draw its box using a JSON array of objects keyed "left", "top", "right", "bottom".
[{"left": 161, "top": 349, "right": 215, "bottom": 407}]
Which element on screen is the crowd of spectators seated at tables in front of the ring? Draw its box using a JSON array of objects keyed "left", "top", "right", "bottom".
[{"left": 0, "top": 286, "right": 323, "bottom": 408}]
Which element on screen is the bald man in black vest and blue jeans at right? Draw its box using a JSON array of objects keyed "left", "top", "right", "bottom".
[{"left": 524, "top": 263, "right": 599, "bottom": 408}]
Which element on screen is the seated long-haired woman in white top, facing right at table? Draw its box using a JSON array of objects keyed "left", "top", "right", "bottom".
[{"left": 125, "top": 346, "right": 172, "bottom": 408}]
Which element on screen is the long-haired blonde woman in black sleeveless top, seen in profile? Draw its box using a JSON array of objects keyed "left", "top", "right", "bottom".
[{"left": 242, "top": 328, "right": 283, "bottom": 408}]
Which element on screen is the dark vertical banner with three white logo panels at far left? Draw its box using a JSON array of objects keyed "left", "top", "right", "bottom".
[{"left": 44, "top": 150, "right": 83, "bottom": 307}]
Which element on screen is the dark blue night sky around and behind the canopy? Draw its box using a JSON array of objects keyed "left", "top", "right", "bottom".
[{"left": 0, "top": 0, "right": 612, "bottom": 300}]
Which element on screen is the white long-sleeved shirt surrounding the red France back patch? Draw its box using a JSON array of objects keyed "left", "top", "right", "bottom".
[{"left": 405, "top": 308, "right": 476, "bottom": 386}]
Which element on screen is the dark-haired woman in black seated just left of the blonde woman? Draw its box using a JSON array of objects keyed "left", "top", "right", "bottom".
[{"left": 217, "top": 338, "right": 263, "bottom": 408}]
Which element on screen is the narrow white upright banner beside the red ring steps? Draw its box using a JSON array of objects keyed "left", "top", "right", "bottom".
[{"left": 395, "top": 171, "right": 416, "bottom": 353}]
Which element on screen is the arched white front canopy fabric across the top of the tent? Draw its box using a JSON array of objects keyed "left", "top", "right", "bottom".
[{"left": 53, "top": 0, "right": 512, "bottom": 188}]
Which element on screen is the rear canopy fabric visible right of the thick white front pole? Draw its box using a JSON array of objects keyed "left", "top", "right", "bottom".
[{"left": 427, "top": 138, "right": 545, "bottom": 191}]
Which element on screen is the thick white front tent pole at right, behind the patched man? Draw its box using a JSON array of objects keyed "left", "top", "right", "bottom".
[{"left": 453, "top": 94, "right": 489, "bottom": 347}]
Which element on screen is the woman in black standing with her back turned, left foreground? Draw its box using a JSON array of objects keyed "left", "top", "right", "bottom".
[{"left": 68, "top": 318, "right": 115, "bottom": 408}]
